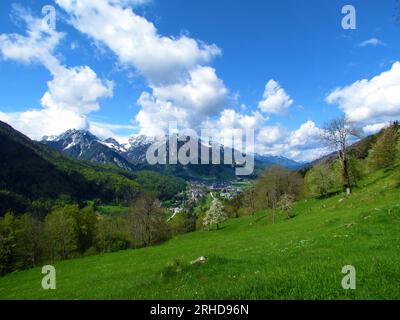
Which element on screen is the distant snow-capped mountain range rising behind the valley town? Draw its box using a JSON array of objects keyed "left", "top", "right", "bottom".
[{"left": 42, "top": 130, "right": 304, "bottom": 180}]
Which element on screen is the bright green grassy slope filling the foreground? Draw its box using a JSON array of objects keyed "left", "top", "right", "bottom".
[{"left": 0, "top": 171, "right": 400, "bottom": 299}]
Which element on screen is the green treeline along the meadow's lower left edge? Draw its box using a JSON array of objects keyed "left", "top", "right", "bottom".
[{"left": 0, "top": 193, "right": 195, "bottom": 275}]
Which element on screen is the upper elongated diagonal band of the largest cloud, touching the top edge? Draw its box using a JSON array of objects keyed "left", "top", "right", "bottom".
[{"left": 56, "top": 0, "right": 220, "bottom": 85}]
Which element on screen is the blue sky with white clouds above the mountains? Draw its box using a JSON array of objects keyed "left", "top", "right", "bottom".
[{"left": 0, "top": 0, "right": 400, "bottom": 160}]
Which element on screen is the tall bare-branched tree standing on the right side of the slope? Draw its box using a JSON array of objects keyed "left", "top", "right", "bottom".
[{"left": 321, "top": 117, "right": 361, "bottom": 195}]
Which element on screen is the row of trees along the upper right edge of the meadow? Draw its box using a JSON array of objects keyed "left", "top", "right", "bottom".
[{"left": 225, "top": 120, "right": 400, "bottom": 220}]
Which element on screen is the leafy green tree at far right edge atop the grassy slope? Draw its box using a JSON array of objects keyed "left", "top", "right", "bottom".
[{"left": 368, "top": 123, "right": 400, "bottom": 170}]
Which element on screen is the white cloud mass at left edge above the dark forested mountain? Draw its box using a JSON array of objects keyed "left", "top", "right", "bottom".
[{"left": 0, "top": 11, "right": 114, "bottom": 139}]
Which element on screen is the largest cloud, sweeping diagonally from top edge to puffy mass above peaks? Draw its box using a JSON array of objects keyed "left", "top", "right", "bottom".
[{"left": 56, "top": 0, "right": 228, "bottom": 135}]
